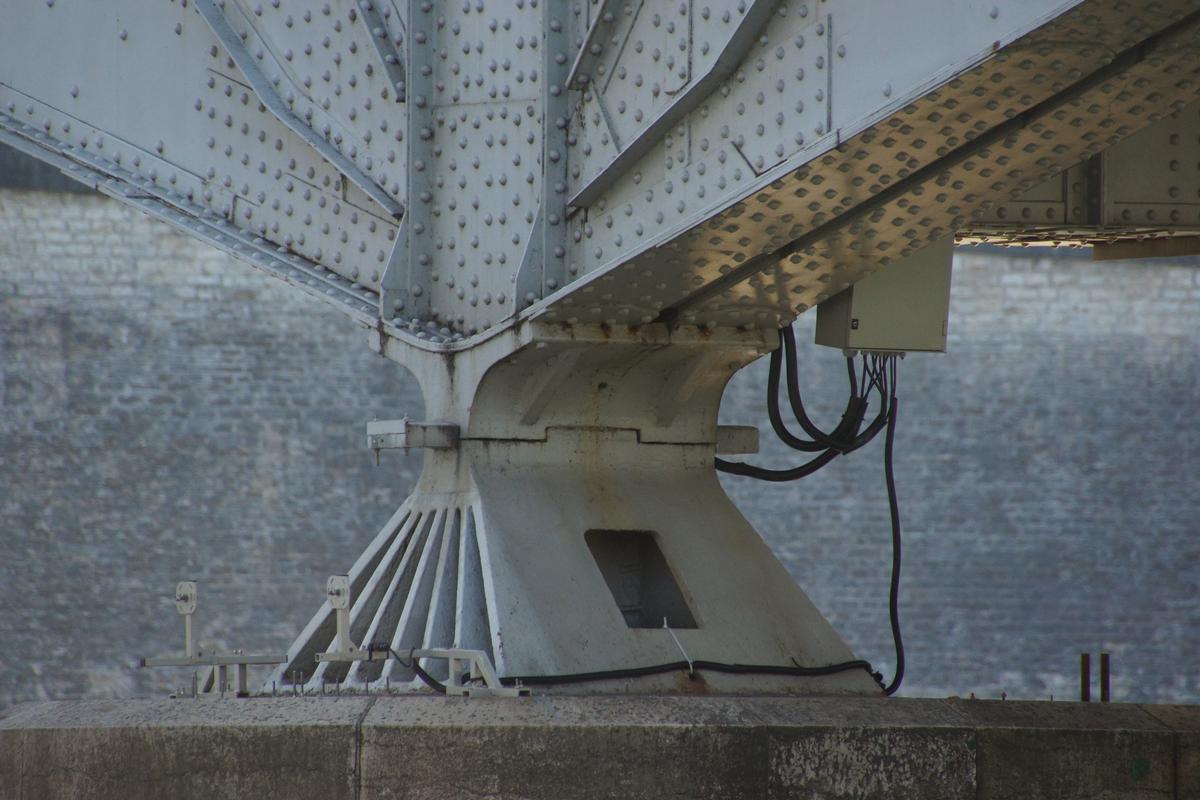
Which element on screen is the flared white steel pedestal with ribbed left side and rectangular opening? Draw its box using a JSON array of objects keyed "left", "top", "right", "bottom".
[{"left": 276, "top": 325, "right": 878, "bottom": 693}]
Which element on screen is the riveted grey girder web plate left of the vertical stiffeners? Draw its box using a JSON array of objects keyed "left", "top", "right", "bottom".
[{"left": 0, "top": 0, "right": 403, "bottom": 299}]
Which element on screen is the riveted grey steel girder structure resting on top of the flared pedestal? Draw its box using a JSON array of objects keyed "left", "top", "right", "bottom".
[{"left": 0, "top": 0, "right": 1196, "bottom": 350}]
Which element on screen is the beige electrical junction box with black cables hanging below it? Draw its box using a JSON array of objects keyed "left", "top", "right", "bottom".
[{"left": 816, "top": 236, "right": 954, "bottom": 353}]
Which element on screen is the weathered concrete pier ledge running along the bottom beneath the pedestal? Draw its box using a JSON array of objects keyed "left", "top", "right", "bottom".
[{"left": 0, "top": 696, "right": 1200, "bottom": 800}]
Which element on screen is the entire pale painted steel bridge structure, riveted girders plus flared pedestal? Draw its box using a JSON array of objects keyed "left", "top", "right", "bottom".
[{"left": 7, "top": 0, "right": 1200, "bottom": 692}]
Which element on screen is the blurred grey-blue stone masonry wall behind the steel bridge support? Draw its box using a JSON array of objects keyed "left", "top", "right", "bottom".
[{"left": 0, "top": 188, "right": 1200, "bottom": 709}]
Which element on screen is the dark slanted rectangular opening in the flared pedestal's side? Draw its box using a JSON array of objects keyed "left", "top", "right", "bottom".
[{"left": 584, "top": 530, "right": 698, "bottom": 627}]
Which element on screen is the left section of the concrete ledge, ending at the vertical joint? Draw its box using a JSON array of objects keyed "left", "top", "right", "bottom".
[{"left": 0, "top": 698, "right": 370, "bottom": 800}]
